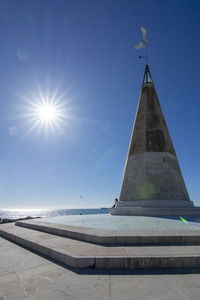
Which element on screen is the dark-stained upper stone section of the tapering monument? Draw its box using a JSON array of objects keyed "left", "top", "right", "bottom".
[{"left": 129, "top": 83, "right": 176, "bottom": 155}]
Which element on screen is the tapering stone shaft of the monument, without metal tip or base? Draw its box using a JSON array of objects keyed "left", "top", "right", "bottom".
[{"left": 119, "top": 83, "right": 193, "bottom": 207}]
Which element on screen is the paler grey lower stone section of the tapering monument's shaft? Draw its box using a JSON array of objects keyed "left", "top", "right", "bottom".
[{"left": 118, "top": 152, "right": 194, "bottom": 204}]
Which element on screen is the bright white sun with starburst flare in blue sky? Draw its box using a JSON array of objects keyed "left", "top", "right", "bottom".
[{"left": 17, "top": 83, "right": 81, "bottom": 141}]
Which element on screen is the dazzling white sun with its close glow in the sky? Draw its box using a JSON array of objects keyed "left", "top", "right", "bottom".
[{"left": 20, "top": 84, "right": 77, "bottom": 138}]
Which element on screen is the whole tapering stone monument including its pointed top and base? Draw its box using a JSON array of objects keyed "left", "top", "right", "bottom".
[{"left": 110, "top": 65, "right": 200, "bottom": 216}]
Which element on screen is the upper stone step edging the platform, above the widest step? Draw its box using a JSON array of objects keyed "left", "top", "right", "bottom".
[{"left": 15, "top": 220, "right": 200, "bottom": 245}]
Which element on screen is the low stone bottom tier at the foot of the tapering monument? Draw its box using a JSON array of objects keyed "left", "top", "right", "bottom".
[{"left": 109, "top": 207, "right": 200, "bottom": 217}]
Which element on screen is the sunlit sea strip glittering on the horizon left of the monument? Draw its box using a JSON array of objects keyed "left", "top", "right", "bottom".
[{"left": 0, "top": 207, "right": 108, "bottom": 220}]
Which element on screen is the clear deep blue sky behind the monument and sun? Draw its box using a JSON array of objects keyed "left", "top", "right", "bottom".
[{"left": 0, "top": 0, "right": 200, "bottom": 208}]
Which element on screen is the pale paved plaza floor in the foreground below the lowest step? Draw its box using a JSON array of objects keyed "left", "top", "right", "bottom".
[{"left": 0, "top": 238, "right": 200, "bottom": 300}]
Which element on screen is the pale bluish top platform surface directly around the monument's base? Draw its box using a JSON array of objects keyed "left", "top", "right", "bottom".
[{"left": 37, "top": 214, "right": 200, "bottom": 232}]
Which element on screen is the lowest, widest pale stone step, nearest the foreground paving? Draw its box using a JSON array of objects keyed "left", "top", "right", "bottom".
[{"left": 0, "top": 224, "right": 200, "bottom": 269}]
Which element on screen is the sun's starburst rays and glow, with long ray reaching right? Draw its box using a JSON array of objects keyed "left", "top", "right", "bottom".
[{"left": 9, "top": 76, "right": 102, "bottom": 144}]
